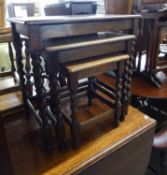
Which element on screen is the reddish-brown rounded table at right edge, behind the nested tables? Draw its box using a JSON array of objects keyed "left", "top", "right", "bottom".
[{"left": 131, "top": 72, "right": 167, "bottom": 125}]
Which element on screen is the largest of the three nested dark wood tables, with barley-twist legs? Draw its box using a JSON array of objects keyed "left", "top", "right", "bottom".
[{"left": 9, "top": 15, "right": 141, "bottom": 149}]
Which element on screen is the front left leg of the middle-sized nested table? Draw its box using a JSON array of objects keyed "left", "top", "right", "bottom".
[{"left": 45, "top": 53, "right": 66, "bottom": 150}]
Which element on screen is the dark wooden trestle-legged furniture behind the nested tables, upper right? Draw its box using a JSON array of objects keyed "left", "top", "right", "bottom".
[{"left": 134, "top": 0, "right": 167, "bottom": 87}]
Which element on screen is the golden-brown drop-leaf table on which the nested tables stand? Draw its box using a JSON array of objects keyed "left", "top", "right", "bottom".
[{"left": 6, "top": 100, "right": 155, "bottom": 175}]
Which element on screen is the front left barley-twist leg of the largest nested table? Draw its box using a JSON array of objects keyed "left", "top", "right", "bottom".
[{"left": 31, "top": 51, "right": 53, "bottom": 152}]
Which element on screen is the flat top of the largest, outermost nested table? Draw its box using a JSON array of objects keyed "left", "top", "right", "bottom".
[{"left": 8, "top": 15, "right": 141, "bottom": 25}]
